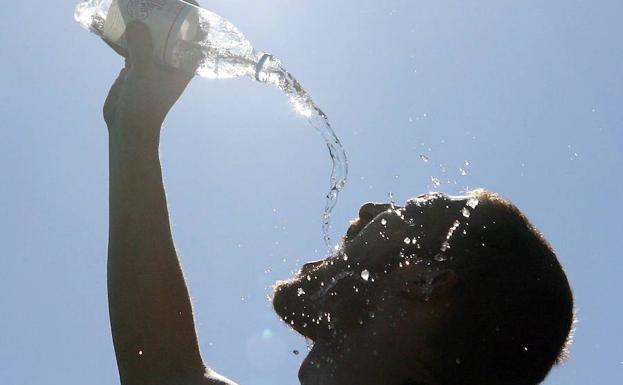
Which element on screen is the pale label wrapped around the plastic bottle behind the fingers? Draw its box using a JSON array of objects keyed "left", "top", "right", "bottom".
[{"left": 104, "top": 0, "right": 197, "bottom": 66}]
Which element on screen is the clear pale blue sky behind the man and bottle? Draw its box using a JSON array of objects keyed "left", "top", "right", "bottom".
[{"left": 0, "top": 0, "right": 623, "bottom": 385}]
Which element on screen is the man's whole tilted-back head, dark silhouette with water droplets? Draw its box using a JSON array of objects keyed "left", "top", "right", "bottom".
[{"left": 273, "top": 190, "right": 573, "bottom": 385}]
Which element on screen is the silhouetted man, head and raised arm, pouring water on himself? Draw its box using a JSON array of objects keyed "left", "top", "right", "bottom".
[{"left": 104, "top": 22, "right": 573, "bottom": 385}]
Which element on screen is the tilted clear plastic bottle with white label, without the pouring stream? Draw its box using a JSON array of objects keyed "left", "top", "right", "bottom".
[{"left": 75, "top": 0, "right": 261, "bottom": 79}]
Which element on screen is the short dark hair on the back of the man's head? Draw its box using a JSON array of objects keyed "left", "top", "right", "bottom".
[{"left": 433, "top": 190, "right": 574, "bottom": 385}]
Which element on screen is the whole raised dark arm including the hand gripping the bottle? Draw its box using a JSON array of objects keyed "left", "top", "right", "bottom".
[{"left": 104, "top": 23, "right": 236, "bottom": 385}]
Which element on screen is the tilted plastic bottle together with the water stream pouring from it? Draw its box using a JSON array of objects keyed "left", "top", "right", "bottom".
[{"left": 75, "top": 0, "right": 348, "bottom": 251}]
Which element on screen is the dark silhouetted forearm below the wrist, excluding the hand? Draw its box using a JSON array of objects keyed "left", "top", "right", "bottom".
[{"left": 108, "top": 124, "right": 203, "bottom": 384}]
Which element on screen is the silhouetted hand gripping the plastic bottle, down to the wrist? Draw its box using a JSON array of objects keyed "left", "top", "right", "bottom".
[{"left": 104, "top": 21, "right": 194, "bottom": 130}]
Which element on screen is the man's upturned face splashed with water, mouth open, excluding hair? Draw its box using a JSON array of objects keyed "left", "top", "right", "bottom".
[{"left": 273, "top": 193, "right": 478, "bottom": 384}]
